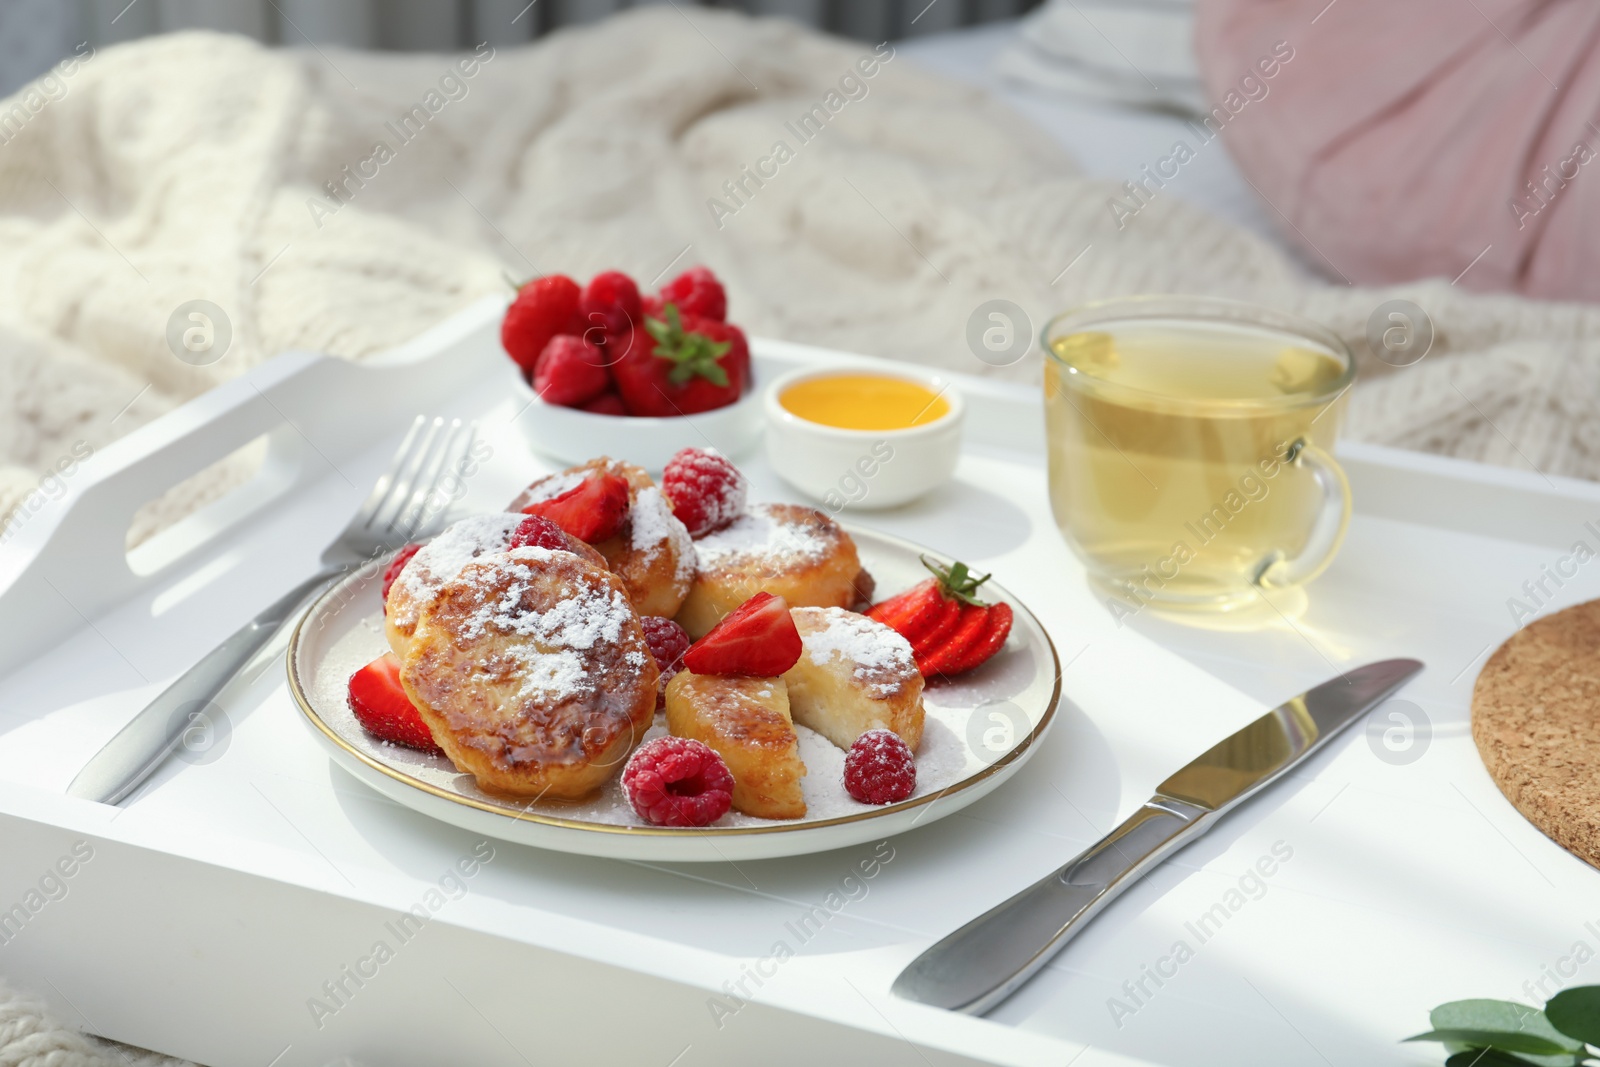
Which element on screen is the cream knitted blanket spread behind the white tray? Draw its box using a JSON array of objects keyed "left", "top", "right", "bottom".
[{"left": 0, "top": 6, "right": 1600, "bottom": 1064}]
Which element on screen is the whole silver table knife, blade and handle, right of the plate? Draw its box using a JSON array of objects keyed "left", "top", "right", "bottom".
[{"left": 893, "top": 659, "right": 1422, "bottom": 1014}]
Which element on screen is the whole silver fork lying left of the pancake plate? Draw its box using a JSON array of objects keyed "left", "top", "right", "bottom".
[{"left": 67, "top": 416, "right": 475, "bottom": 805}]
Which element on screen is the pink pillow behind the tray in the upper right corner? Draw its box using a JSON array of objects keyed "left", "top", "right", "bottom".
[{"left": 1195, "top": 0, "right": 1600, "bottom": 301}]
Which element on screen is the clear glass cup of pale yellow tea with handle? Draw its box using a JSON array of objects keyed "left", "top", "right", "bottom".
[{"left": 1042, "top": 296, "right": 1355, "bottom": 617}]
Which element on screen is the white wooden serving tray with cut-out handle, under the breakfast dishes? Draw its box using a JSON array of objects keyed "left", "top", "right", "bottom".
[{"left": 0, "top": 294, "right": 1600, "bottom": 1067}]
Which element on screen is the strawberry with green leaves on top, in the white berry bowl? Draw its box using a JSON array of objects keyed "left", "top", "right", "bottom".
[{"left": 611, "top": 304, "right": 749, "bottom": 418}]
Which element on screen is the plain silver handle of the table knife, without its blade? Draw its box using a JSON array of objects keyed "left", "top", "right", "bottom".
[{"left": 893, "top": 797, "right": 1216, "bottom": 1014}]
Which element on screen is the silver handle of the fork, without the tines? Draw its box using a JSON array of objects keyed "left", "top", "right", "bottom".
[{"left": 67, "top": 566, "right": 344, "bottom": 805}]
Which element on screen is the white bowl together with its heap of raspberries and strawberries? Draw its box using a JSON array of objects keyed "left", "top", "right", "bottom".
[{"left": 501, "top": 267, "right": 763, "bottom": 470}]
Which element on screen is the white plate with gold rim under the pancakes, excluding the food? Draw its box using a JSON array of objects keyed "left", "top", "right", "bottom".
[{"left": 288, "top": 526, "right": 1061, "bottom": 862}]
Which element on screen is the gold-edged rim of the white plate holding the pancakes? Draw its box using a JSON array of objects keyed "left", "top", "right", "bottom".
[{"left": 283, "top": 522, "right": 1062, "bottom": 838}]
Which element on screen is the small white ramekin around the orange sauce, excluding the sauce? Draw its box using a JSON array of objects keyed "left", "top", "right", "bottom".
[{"left": 763, "top": 366, "right": 966, "bottom": 512}]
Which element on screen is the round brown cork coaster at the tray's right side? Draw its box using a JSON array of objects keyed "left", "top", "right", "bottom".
[{"left": 1472, "top": 600, "right": 1600, "bottom": 867}]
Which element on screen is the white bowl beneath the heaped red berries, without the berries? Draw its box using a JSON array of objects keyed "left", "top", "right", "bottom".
[{"left": 517, "top": 382, "right": 762, "bottom": 474}]
